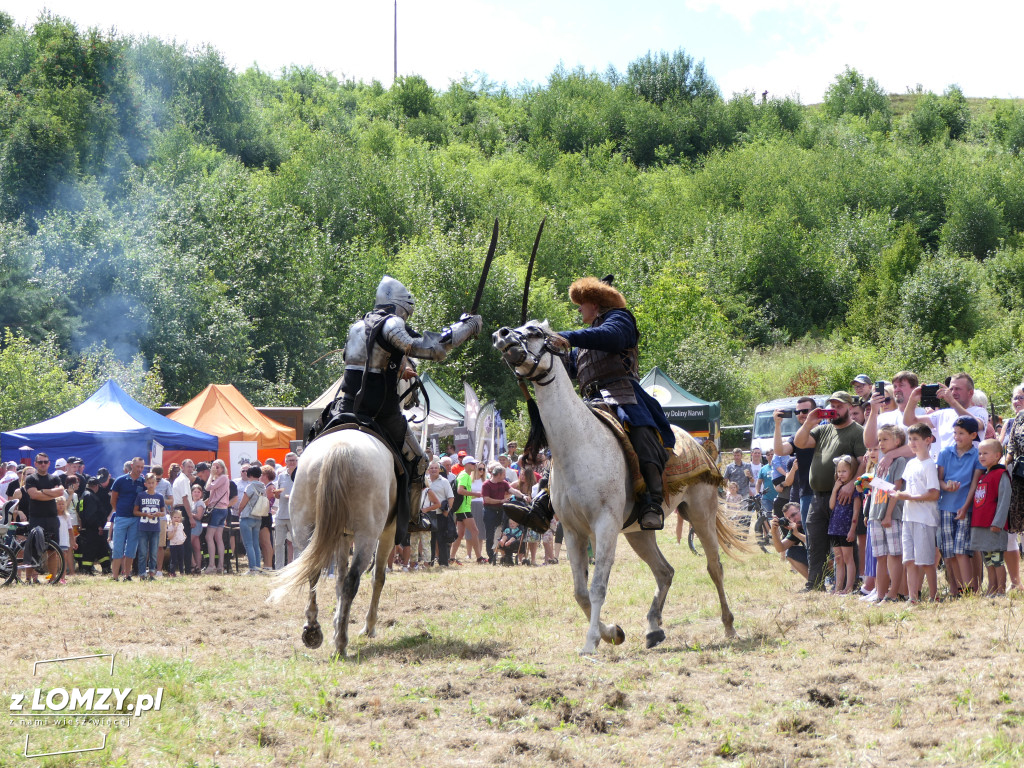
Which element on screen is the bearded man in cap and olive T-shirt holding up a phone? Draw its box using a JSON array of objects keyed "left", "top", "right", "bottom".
[{"left": 793, "top": 390, "right": 867, "bottom": 592}]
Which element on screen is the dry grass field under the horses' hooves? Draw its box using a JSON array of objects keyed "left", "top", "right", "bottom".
[{"left": 0, "top": 531, "right": 1024, "bottom": 768}]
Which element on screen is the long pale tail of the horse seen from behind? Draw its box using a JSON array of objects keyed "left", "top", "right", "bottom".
[{"left": 268, "top": 443, "right": 358, "bottom": 602}]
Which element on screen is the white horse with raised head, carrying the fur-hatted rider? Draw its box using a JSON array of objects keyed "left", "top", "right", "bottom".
[{"left": 492, "top": 322, "right": 744, "bottom": 653}]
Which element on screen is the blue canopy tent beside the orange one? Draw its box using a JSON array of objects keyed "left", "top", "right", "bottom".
[{"left": 0, "top": 379, "right": 217, "bottom": 476}]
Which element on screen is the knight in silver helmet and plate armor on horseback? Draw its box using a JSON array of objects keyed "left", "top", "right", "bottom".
[{"left": 340, "top": 275, "right": 483, "bottom": 541}]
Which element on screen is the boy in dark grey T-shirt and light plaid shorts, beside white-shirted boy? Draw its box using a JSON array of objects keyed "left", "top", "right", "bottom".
[{"left": 867, "top": 424, "right": 907, "bottom": 603}]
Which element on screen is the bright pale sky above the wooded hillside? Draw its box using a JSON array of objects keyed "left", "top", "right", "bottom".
[{"left": 0, "top": 0, "right": 1024, "bottom": 103}]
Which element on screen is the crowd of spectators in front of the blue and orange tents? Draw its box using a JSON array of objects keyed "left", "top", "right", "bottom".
[{"left": 0, "top": 453, "right": 298, "bottom": 583}]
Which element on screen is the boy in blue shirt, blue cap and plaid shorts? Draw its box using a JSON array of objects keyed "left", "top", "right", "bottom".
[{"left": 935, "top": 416, "right": 984, "bottom": 597}]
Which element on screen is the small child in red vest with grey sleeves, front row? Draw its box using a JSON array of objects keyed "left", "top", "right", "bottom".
[{"left": 971, "top": 439, "right": 1011, "bottom": 597}]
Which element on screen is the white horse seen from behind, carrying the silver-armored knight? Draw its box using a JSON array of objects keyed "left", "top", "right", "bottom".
[{"left": 269, "top": 429, "right": 397, "bottom": 656}]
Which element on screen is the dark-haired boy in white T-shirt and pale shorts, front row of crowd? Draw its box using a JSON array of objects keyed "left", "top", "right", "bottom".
[{"left": 893, "top": 422, "right": 939, "bottom": 605}]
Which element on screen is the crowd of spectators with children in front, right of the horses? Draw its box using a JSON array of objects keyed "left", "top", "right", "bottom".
[{"left": 761, "top": 371, "right": 1024, "bottom": 603}]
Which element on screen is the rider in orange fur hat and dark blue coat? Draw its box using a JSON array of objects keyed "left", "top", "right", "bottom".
[{"left": 527, "top": 275, "right": 676, "bottom": 530}]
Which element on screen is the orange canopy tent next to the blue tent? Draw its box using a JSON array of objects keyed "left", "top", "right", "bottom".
[{"left": 164, "top": 384, "right": 295, "bottom": 466}]
